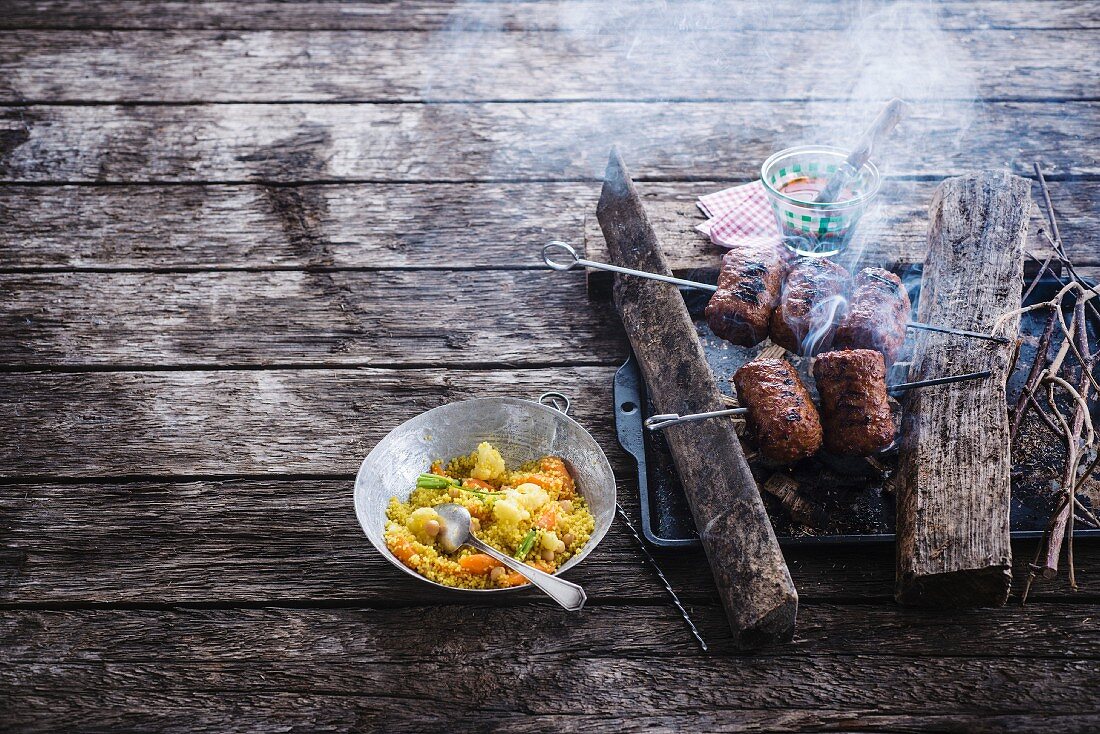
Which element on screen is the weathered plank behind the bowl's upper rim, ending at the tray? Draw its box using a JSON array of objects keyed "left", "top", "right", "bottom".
[{"left": 0, "top": 365, "right": 626, "bottom": 479}]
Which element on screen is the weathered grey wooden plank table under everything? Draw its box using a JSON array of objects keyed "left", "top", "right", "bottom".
[{"left": 0, "top": 0, "right": 1100, "bottom": 732}]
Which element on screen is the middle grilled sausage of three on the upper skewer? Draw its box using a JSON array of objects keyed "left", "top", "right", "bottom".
[{"left": 771, "top": 258, "right": 850, "bottom": 357}]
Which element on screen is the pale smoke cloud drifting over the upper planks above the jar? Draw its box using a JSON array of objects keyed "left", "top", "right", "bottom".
[{"left": 410, "top": 0, "right": 978, "bottom": 236}]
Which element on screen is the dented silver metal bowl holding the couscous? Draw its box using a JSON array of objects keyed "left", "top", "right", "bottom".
[{"left": 355, "top": 397, "right": 616, "bottom": 592}]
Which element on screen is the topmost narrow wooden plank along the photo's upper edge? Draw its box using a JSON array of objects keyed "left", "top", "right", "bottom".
[{"left": 0, "top": 0, "right": 1097, "bottom": 33}]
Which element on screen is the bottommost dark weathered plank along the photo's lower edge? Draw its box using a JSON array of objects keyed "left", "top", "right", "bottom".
[{"left": 4, "top": 695, "right": 1097, "bottom": 734}]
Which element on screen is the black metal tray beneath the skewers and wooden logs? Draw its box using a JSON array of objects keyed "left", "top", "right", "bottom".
[{"left": 614, "top": 272, "right": 1100, "bottom": 547}]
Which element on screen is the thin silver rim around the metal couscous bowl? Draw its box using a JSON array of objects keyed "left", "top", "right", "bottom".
[{"left": 352, "top": 397, "right": 618, "bottom": 593}]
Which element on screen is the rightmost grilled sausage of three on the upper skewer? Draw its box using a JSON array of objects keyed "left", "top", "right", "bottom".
[{"left": 833, "top": 267, "right": 913, "bottom": 365}]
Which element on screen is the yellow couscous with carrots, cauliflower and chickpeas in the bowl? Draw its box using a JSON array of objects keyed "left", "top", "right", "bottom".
[{"left": 385, "top": 442, "right": 596, "bottom": 589}]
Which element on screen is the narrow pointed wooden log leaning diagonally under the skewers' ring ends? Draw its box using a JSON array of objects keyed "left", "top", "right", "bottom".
[{"left": 596, "top": 150, "right": 799, "bottom": 648}]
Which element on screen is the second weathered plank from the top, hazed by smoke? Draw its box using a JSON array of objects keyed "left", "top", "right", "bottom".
[{"left": 0, "top": 29, "right": 1100, "bottom": 103}]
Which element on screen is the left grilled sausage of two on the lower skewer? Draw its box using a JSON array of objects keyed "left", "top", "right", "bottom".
[{"left": 734, "top": 360, "right": 822, "bottom": 463}]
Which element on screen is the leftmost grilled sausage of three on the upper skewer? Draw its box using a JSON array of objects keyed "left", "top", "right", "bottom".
[{"left": 704, "top": 245, "right": 785, "bottom": 347}]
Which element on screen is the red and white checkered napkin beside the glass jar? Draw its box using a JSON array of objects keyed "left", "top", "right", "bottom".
[{"left": 695, "top": 180, "right": 780, "bottom": 248}]
